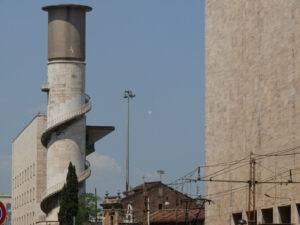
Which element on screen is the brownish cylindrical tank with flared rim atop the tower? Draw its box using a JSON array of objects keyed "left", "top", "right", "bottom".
[{"left": 43, "top": 4, "right": 92, "bottom": 61}]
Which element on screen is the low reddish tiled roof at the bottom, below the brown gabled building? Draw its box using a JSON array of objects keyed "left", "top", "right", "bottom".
[{"left": 150, "top": 209, "right": 204, "bottom": 223}]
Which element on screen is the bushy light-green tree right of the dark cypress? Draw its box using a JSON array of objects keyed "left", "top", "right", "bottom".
[{"left": 76, "top": 193, "right": 101, "bottom": 225}]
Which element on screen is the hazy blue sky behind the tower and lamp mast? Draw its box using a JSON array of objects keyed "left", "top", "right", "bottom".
[{"left": 0, "top": 0, "right": 205, "bottom": 196}]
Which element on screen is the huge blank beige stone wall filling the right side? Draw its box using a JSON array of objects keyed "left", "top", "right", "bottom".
[{"left": 206, "top": 0, "right": 300, "bottom": 225}]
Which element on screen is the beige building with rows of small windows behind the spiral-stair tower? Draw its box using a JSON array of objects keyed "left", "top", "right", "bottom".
[{"left": 12, "top": 115, "right": 47, "bottom": 225}]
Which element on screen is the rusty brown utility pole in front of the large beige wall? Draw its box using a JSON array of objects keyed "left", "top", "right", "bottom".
[{"left": 248, "top": 152, "right": 256, "bottom": 225}]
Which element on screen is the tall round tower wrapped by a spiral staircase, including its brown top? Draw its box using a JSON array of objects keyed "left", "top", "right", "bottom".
[{"left": 41, "top": 4, "right": 114, "bottom": 221}]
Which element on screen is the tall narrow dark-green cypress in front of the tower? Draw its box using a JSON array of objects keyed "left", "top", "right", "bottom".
[{"left": 58, "top": 162, "right": 78, "bottom": 225}]
